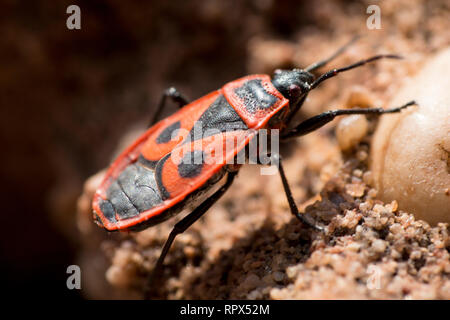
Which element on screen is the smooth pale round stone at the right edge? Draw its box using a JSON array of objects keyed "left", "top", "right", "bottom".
[{"left": 371, "top": 48, "right": 450, "bottom": 224}]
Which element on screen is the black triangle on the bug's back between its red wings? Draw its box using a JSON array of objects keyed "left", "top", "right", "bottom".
[{"left": 184, "top": 94, "right": 248, "bottom": 143}]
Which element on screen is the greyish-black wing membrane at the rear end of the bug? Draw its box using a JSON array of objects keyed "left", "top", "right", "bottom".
[{"left": 100, "top": 163, "right": 162, "bottom": 222}]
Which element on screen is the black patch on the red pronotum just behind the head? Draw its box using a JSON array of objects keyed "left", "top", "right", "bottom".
[{"left": 234, "top": 79, "right": 277, "bottom": 113}]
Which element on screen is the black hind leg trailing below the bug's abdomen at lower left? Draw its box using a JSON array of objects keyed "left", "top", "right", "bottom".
[{"left": 144, "top": 172, "right": 236, "bottom": 298}]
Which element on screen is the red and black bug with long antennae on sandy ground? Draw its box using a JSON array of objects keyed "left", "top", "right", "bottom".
[{"left": 93, "top": 40, "right": 414, "bottom": 290}]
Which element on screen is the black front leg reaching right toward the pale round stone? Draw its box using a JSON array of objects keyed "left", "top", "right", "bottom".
[{"left": 281, "top": 101, "right": 416, "bottom": 140}]
